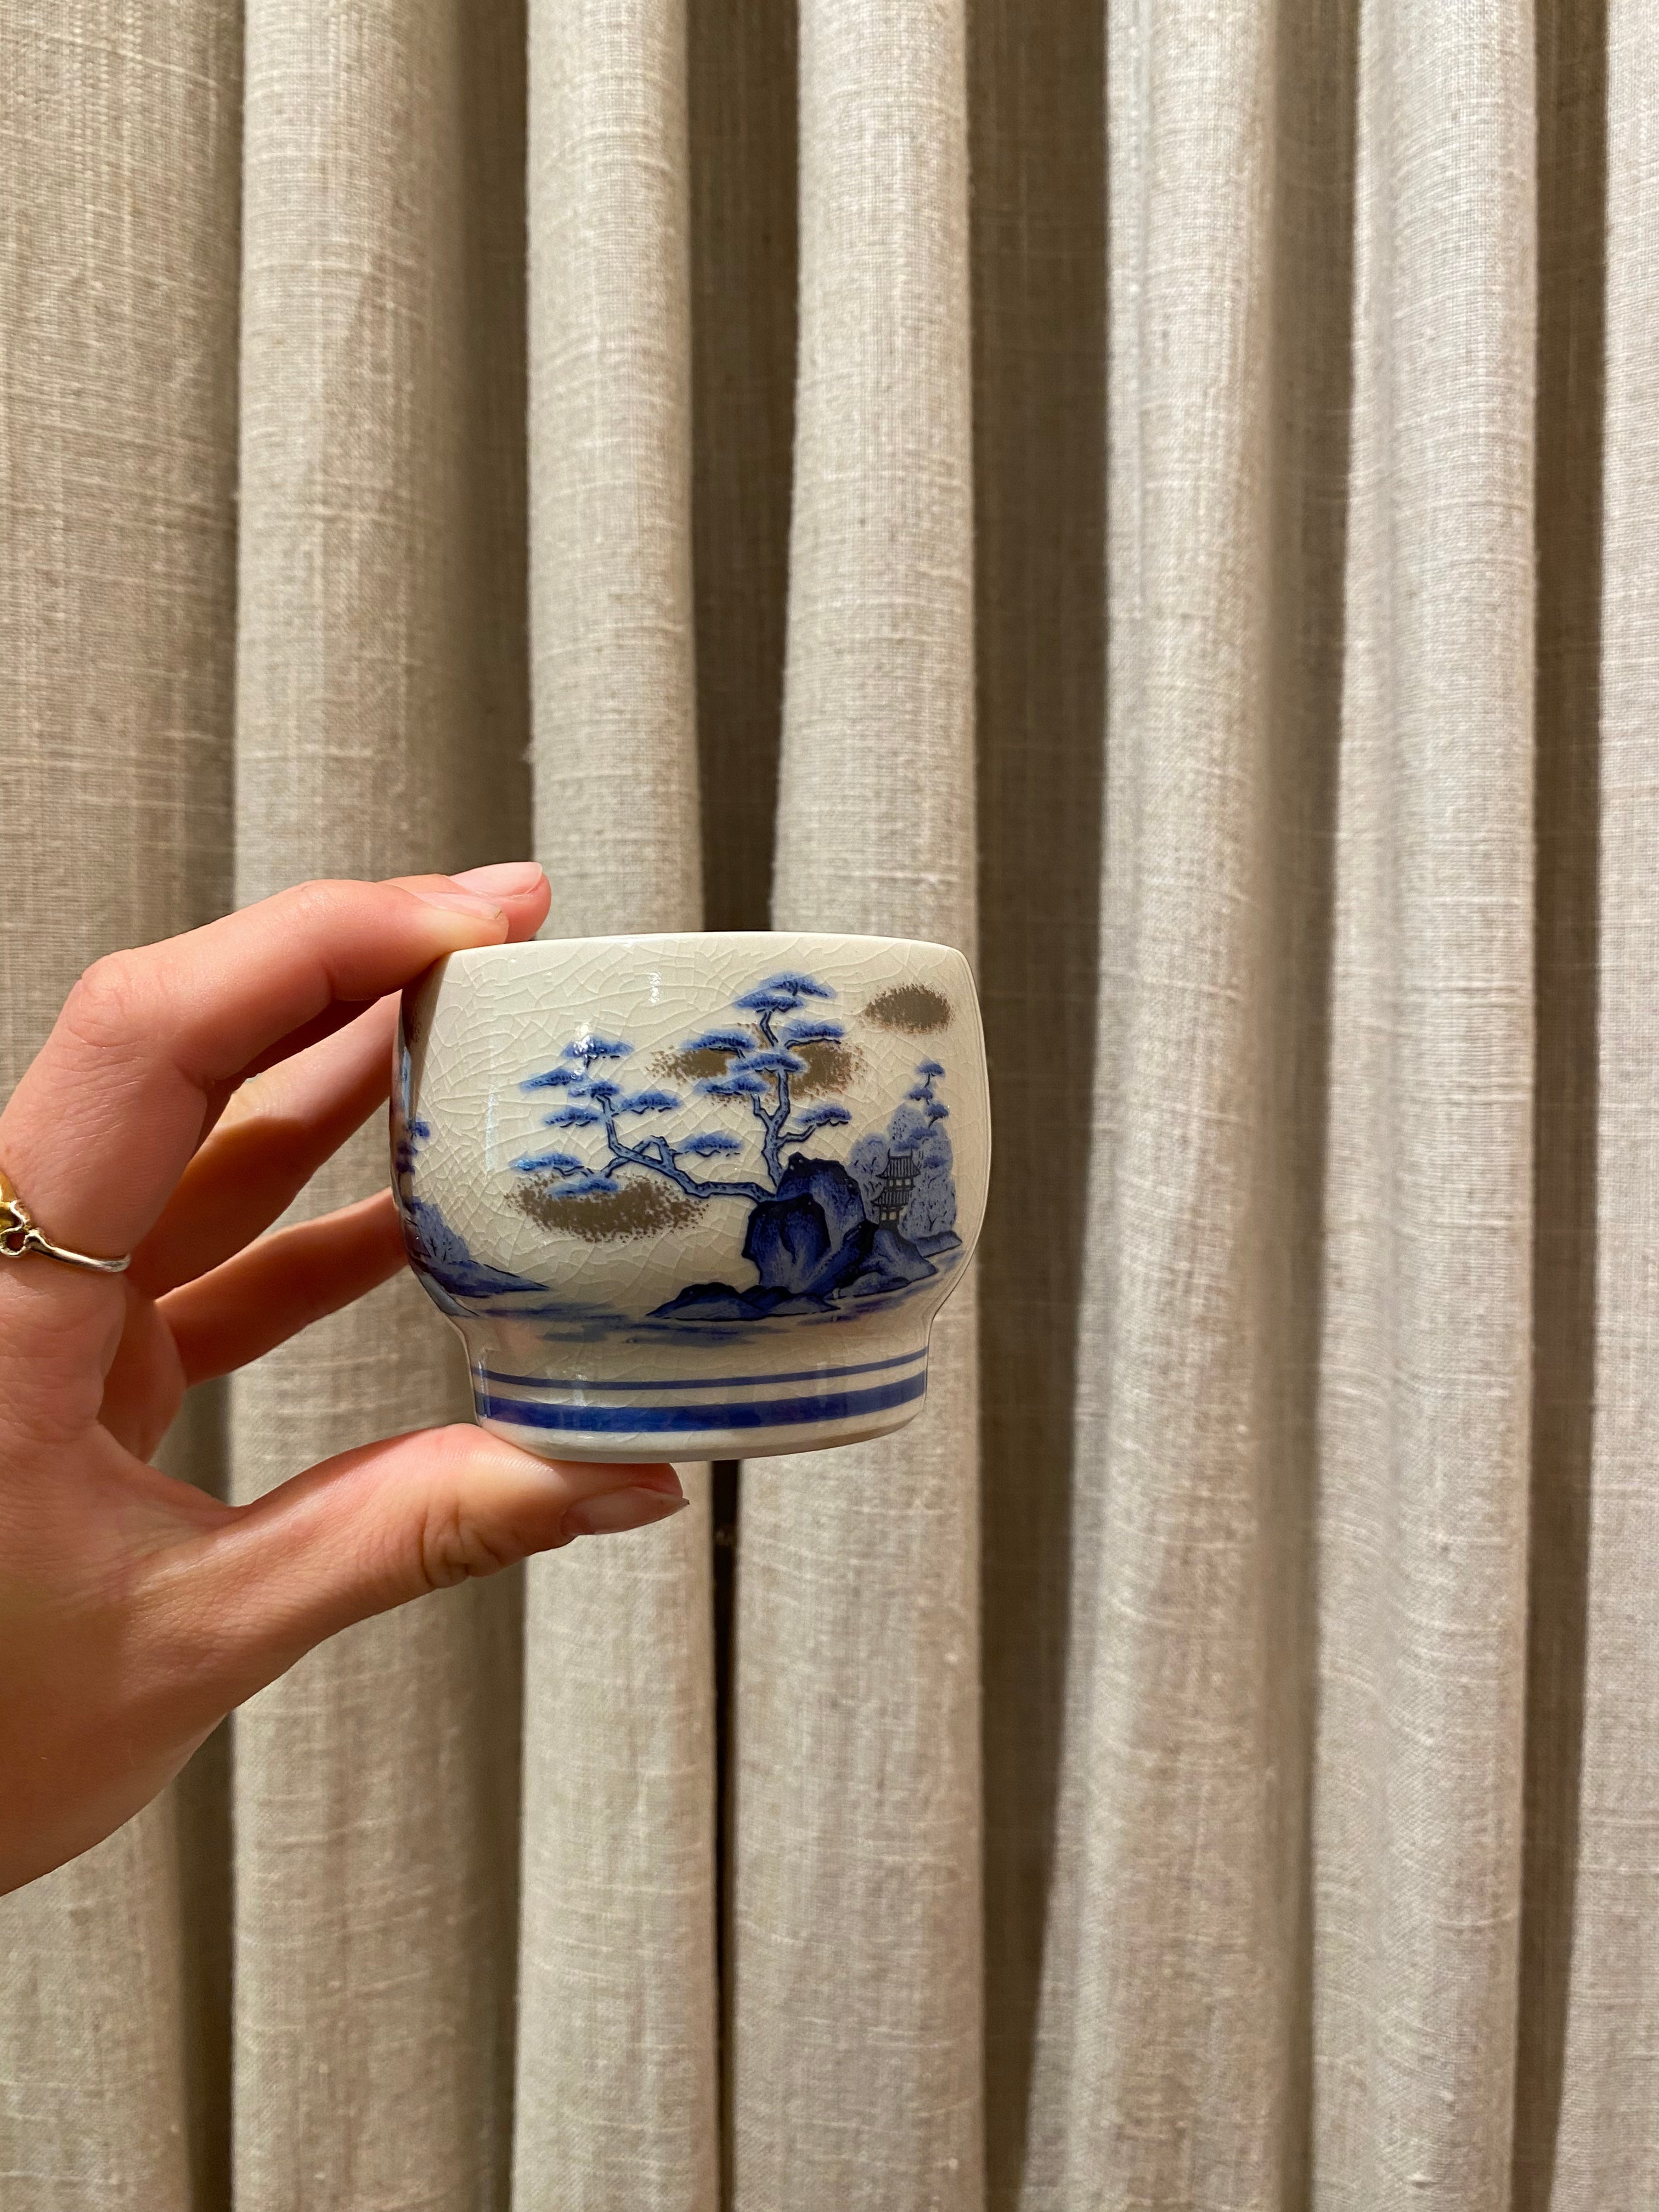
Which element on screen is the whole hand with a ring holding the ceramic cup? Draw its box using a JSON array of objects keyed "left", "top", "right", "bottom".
[{"left": 0, "top": 865, "right": 684, "bottom": 1891}]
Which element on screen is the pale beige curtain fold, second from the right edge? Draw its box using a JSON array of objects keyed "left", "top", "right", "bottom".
[{"left": 1312, "top": 7, "right": 1537, "bottom": 2208}]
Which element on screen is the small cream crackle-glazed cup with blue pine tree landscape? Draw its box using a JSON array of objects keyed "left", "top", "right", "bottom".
[{"left": 392, "top": 931, "right": 991, "bottom": 1460}]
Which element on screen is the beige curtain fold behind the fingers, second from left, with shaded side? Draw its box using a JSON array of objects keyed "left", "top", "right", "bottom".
[{"left": 230, "top": 0, "right": 529, "bottom": 2212}]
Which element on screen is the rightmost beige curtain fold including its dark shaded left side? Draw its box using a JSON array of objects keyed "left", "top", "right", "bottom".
[{"left": 1515, "top": 0, "right": 1659, "bottom": 2212}]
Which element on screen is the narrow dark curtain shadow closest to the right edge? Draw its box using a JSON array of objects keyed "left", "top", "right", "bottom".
[{"left": 1513, "top": 0, "right": 1608, "bottom": 2212}]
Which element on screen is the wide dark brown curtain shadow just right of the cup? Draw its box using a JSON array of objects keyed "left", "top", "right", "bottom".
[{"left": 969, "top": 0, "right": 1106, "bottom": 2208}]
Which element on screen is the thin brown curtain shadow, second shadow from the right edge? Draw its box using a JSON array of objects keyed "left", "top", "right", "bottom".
[{"left": 1261, "top": 0, "right": 1361, "bottom": 2205}]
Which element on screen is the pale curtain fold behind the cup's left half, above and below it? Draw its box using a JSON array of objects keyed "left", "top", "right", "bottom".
[{"left": 513, "top": 0, "right": 719, "bottom": 2212}]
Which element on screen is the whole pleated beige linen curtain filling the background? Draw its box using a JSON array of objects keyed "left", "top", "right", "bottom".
[{"left": 0, "top": 0, "right": 1659, "bottom": 2212}]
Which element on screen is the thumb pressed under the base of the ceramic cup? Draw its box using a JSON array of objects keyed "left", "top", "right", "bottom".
[{"left": 166, "top": 1425, "right": 688, "bottom": 1697}]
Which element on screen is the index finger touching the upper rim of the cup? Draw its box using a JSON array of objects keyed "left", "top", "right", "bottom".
[{"left": 0, "top": 862, "right": 560, "bottom": 1272}]
